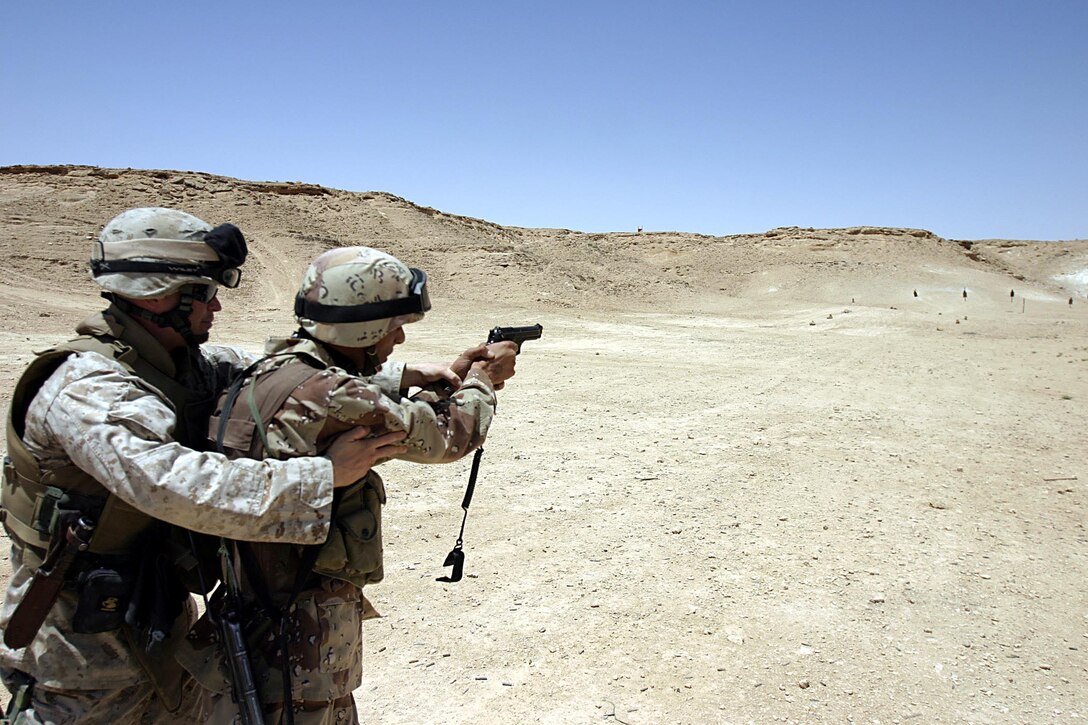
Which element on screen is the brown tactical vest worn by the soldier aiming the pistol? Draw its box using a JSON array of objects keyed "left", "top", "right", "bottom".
[{"left": 209, "top": 352, "right": 385, "bottom": 589}]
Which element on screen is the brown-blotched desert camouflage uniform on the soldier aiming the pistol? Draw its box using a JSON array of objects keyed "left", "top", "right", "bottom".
[{"left": 182, "top": 339, "right": 496, "bottom": 725}]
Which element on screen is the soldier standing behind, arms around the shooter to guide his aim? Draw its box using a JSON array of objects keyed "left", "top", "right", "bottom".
[{"left": 0, "top": 208, "right": 391, "bottom": 725}]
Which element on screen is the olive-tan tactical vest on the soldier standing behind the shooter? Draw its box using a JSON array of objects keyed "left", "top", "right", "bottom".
[{"left": 0, "top": 318, "right": 214, "bottom": 558}]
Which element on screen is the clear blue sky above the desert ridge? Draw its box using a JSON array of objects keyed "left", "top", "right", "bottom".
[{"left": 0, "top": 0, "right": 1088, "bottom": 239}]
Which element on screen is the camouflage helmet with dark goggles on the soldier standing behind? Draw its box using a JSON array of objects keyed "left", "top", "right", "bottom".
[{"left": 90, "top": 207, "right": 247, "bottom": 299}]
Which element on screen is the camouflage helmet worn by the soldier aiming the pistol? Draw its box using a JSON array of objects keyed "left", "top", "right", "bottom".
[{"left": 295, "top": 247, "right": 431, "bottom": 347}]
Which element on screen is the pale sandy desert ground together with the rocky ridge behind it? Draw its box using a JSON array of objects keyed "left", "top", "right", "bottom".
[{"left": 0, "top": 167, "right": 1088, "bottom": 725}]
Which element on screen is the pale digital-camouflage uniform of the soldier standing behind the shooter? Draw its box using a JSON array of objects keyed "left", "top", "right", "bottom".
[{"left": 0, "top": 309, "right": 350, "bottom": 725}]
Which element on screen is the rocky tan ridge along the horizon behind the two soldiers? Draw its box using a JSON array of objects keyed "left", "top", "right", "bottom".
[{"left": 0, "top": 165, "right": 1088, "bottom": 310}]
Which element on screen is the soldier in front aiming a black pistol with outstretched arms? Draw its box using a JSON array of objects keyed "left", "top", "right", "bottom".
[{"left": 183, "top": 247, "right": 516, "bottom": 725}]
